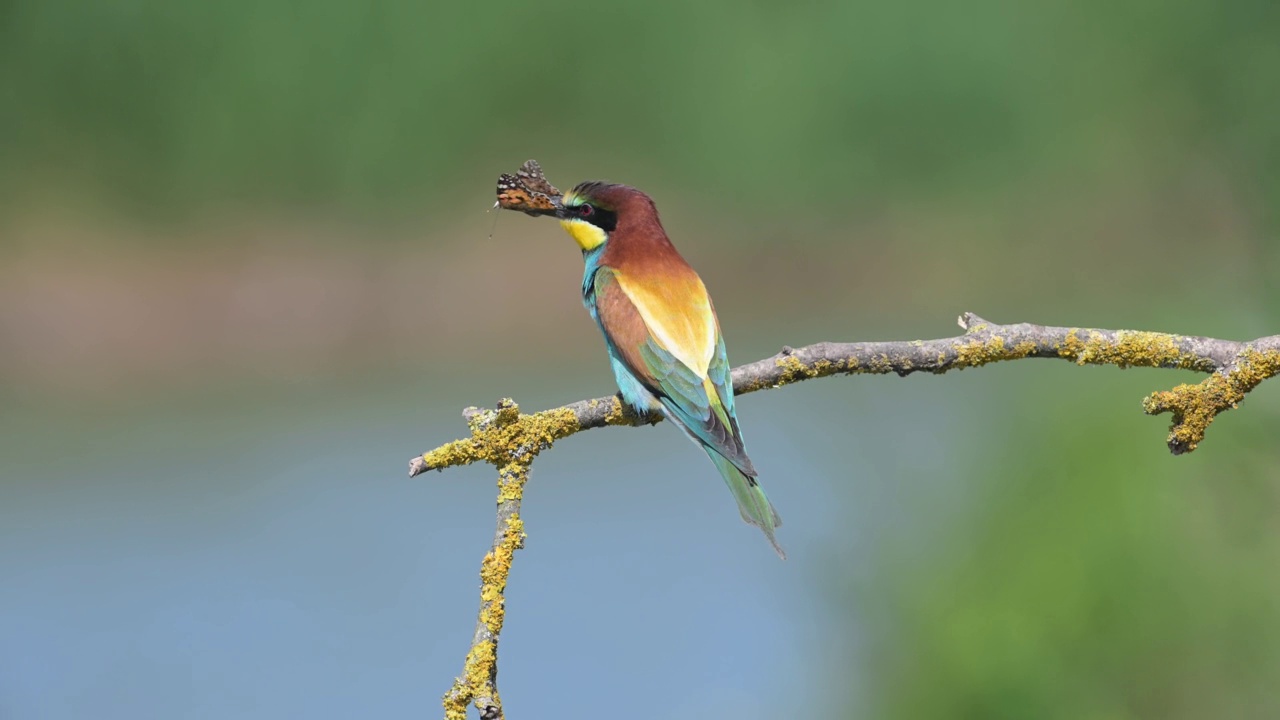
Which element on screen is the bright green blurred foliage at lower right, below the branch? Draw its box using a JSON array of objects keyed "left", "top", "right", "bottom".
[{"left": 855, "top": 386, "right": 1280, "bottom": 720}]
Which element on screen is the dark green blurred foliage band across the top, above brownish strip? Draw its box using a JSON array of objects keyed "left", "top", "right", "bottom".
[{"left": 0, "top": 0, "right": 1280, "bottom": 221}]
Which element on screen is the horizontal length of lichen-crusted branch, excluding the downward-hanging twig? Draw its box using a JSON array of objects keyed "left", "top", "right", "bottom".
[{"left": 410, "top": 313, "right": 1280, "bottom": 477}]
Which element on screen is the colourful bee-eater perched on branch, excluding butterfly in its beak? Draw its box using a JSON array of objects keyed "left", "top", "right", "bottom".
[{"left": 556, "top": 182, "right": 786, "bottom": 559}]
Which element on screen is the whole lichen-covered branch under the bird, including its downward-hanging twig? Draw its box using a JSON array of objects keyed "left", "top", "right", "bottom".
[{"left": 408, "top": 313, "right": 1280, "bottom": 720}]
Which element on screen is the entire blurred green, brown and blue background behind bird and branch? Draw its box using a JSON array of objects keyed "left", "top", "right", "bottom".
[{"left": 0, "top": 0, "right": 1280, "bottom": 720}]
